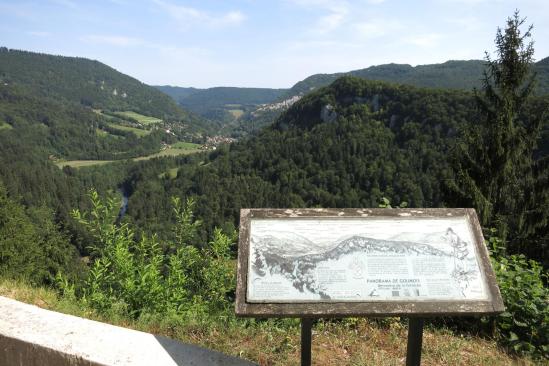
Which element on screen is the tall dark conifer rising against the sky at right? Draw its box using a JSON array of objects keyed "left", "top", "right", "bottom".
[{"left": 452, "top": 11, "right": 547, "bottom": 255}]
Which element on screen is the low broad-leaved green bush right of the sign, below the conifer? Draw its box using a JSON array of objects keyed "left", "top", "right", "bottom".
[{"left": 489, "top": 231, "right": 549, "bottom": 358}]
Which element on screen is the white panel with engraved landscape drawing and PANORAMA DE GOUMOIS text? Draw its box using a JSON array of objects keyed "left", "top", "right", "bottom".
[{"left": 247, "top": 217, "right": 488, "bottom": 303}]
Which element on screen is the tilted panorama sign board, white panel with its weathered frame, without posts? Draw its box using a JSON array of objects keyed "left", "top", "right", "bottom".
[{"left": 233, "top": 209, "right": 503, "bottom": 316}]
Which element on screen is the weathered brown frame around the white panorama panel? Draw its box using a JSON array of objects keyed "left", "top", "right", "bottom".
[{"left": 235, "top": 208, "right": 504, "bottom": 318}]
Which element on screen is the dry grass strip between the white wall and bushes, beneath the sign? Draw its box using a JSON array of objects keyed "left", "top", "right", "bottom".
[{"left": 0, "top": 279, "right": 534, "bottom": 366}]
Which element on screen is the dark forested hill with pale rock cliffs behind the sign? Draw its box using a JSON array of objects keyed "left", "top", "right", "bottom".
[{"left": 123, "top": 77, "right": 474, "bottom": 232}]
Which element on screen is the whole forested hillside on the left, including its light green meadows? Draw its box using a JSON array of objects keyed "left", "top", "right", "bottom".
[{"left": 0, "top": 48, "right": 211, "bottom": 258}]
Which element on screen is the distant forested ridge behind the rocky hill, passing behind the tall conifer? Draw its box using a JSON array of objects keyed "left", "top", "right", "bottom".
[{"left": 284, "top": 57, "right": 549, "bottom": 98}]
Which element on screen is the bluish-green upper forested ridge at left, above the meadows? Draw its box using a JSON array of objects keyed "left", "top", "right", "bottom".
[{"left": 0, "top": 47, "right": 207, "bottom": 129}]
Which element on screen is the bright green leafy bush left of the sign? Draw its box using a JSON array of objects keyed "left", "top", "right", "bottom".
[{"left": 58, "top": 191, "right": 235, "bottom": 318}]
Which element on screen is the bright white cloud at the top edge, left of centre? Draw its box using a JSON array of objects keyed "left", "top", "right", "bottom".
[{"left": 153, "top": 0, "right": 246, "bottom": 28}]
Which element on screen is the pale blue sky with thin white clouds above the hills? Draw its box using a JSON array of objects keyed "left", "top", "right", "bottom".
[{"left": 0, "top": 0, "right": 549, "bottom": 88}]
